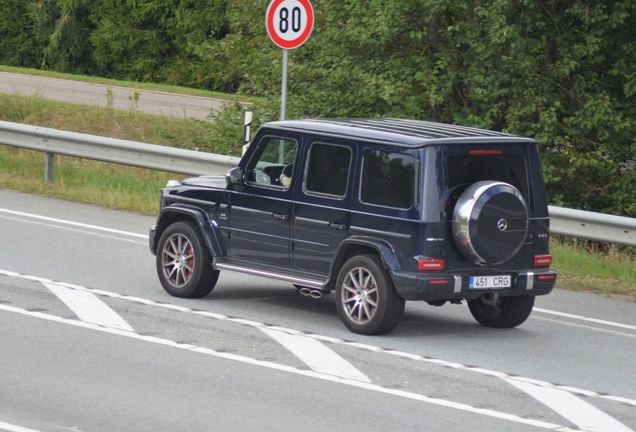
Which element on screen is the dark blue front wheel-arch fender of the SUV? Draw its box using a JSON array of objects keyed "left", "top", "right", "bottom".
[{"left": 149, "top": 203, "right": 225, "bottom": 256}]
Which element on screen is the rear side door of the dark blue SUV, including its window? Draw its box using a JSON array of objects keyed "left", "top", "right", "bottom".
[{"left": 292, "top": 141, "right": 355, "bottom": 275}]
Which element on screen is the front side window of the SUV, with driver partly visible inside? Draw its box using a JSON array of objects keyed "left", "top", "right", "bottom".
[{"left": 246, "top": 137, "right": 298, "bottom": 189}]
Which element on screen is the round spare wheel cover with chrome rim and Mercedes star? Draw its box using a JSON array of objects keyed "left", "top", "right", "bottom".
[{"left": 453, "top": 181, "right": 528, "bottom": 264}]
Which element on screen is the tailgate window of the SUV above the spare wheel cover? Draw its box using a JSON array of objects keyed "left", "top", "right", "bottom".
[{"left": 447, "top": 153, "right": 528, "bottom": 208}]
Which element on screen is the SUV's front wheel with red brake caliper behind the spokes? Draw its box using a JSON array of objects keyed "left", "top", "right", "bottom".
[{"left": 156, "top": 222, "right": 219, "bottom": 298}]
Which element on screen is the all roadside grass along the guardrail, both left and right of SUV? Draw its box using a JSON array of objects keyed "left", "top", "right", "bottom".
[{"left": 0, "top": 71, "right": 636, "bottom": 302}]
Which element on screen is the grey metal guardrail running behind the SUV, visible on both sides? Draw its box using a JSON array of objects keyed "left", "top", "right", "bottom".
[{"left": 0, "top": 121, "right": 636, "bottom": 247}]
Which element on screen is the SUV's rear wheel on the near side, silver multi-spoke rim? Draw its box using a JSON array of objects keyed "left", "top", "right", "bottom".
[{"left": 336, "top": 255, "right": 404, "bottom": 335}]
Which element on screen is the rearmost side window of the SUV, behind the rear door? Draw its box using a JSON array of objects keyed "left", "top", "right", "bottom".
[{"left": 360, "top": 150, "right": 415, "bottom": 209}]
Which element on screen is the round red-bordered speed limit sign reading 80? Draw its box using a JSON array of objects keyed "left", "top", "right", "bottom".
[{"left": 265, "top": 0, "right": 314, "bottom": 49}]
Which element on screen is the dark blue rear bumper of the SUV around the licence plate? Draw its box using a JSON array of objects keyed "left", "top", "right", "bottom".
[{"left": 391, "top": 269, "right": 557, "bottom": 301}]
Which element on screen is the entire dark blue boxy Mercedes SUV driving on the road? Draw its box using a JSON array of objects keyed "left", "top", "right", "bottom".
[{"left": 150, "top": 119, "right": 556, "bottom": 334}]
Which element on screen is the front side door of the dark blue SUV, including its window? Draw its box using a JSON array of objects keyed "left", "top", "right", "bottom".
[{"left": 228, "top": 136, "right": 298, "bottom": 268}]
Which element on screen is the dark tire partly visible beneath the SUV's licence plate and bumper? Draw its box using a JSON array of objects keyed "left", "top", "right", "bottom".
[{"left": 468, "top": 294, "right": 534, "bottom": 328}]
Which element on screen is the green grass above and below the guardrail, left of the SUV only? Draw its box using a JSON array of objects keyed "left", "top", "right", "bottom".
[{"left": 0, "top": 94, "right": 241, "bottom": 215}]
